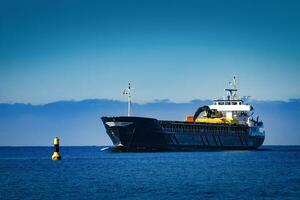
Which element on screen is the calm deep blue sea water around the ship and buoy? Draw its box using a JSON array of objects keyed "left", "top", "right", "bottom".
[{"left": 0, "top": 146, "right": 300, "bottom": 200}]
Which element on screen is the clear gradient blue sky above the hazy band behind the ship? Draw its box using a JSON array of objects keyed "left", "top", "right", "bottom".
[{"left": 0, "top": 0, "right": 300, "bottom": 103}]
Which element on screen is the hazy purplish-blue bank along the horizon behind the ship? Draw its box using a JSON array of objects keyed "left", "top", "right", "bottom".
[{"left": 0, "top": 99, "right": 300, "bottom": 146}]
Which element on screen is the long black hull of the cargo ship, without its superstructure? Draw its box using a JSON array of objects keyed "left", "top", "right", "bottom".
[{"left": 102, "top": 117, "right": 265, "bottom": 151}]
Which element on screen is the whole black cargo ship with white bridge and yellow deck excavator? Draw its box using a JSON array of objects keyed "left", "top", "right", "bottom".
[{"left": 101, "top": 77, "right": 265, "bottom": 151}]
